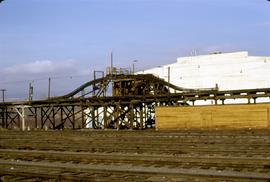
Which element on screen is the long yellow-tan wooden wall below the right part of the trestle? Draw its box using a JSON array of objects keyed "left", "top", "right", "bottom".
[{"left": 156, "top": 104, "right": 270, "bottom": 129}]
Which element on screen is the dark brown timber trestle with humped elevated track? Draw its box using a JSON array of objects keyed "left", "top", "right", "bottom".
[{"left": 0, "top": 70, "right": 270, "bottom": 130}]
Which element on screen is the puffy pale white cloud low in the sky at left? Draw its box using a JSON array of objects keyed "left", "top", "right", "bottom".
[{"left": 3, "top": 60, "right": 76, "bottom": 74}]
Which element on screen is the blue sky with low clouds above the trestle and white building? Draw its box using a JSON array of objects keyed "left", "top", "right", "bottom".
[{"left": 0, "top": 0, "right": 270, "bottom": 98}]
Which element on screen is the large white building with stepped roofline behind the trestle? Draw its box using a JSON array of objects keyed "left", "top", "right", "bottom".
[{"left": 140, "top": 52, "right": 270, "bottom": 90}]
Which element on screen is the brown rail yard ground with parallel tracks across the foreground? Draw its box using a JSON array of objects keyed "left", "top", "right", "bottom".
[{"left": 0, "top": 131, "right": 270, "bottom": 181}]
